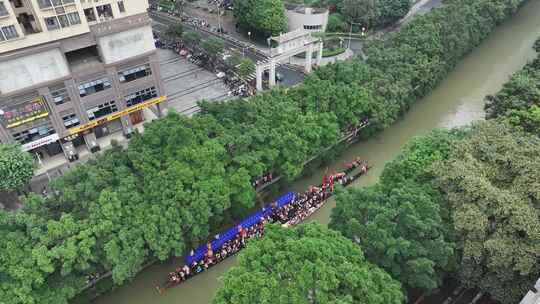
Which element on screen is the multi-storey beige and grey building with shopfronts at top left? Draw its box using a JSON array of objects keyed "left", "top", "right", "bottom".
[{"left": 0, "top": 0, "right": 165, "bottom": 161}]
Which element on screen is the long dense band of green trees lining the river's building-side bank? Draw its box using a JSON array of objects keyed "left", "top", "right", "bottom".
[{"left": 0, "top": 0, "right": 522, "bottom": 304}]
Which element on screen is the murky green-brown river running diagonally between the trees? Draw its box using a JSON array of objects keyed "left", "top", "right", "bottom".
[{"left": 94, "top": 0, "right": 540, "bottom": 304}]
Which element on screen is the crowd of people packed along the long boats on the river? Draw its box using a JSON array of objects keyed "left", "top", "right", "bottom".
[{"left": 158, "top": 158, "right": 369, "bottom": 292}]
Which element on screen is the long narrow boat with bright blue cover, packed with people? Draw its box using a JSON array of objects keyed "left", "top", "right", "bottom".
[{"left": 156, "top": 158, "right": 371, "bottom": 293}]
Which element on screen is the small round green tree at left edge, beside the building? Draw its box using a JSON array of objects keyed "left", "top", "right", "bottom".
[{"left": 0, "top": 144, "right": 35, "bottom": 191}]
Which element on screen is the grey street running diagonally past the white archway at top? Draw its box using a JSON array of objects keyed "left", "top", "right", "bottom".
[{"left": 149, "top": 11, "right": 305, "bottom": 87}]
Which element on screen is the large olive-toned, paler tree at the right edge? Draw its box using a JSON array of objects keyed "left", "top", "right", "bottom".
[{"left": 435, "top": 120, "right": 540, "bottom": 303}]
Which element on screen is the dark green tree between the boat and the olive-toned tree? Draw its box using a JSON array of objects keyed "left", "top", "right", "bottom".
[{"left": 330, "top": 185, "right": 454, "bottom": 291}]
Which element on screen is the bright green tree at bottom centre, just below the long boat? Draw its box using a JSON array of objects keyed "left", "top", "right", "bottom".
[{"left": 213, "top": 223, "right": 405, "bottom": 304}]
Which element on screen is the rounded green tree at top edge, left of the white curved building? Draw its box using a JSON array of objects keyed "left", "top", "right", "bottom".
[{"left": 234, "top": 0, "right": 287, "bottom": 36}]
